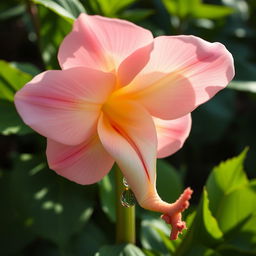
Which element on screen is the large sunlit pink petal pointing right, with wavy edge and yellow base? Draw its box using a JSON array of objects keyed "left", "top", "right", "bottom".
[{"left": 117, "top": 36, "right": 234, "bottom": 120}]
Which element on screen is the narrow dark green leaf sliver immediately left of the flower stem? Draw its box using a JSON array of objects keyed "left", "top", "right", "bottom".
[{"left": 99, "top": 169, "right": 116, "bottom": 222}]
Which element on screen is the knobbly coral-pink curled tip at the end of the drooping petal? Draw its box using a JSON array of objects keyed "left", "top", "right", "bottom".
[{"left": 161, "top": 188, "right": 193, "bottom": 240}]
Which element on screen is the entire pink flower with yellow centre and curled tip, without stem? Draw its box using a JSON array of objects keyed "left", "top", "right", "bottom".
[{"left": 15, "top": 14, "right": 234, "bottom": 239}]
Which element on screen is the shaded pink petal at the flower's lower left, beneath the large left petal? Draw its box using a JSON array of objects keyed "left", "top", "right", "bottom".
[{"left": 46, "top": 136, "right": 114, "bottom": 185}]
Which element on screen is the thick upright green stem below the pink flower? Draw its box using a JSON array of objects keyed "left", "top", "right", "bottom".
[{"left": 115, "top": 165, "right": 135, "bottom": 244}]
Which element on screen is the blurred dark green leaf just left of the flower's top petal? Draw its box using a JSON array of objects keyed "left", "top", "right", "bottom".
[{"left": 39, "top": 6, "right": 71, "bottom": 69}]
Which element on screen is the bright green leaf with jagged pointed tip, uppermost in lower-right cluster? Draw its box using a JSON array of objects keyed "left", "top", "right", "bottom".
[{"left": 206, "top": 148, "right": 248, "bottom": 216}]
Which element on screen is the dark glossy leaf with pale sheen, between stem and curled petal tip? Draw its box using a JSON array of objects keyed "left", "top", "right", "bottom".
[{"left": 140, "top": 217, "right": 175, "bottom": 255}]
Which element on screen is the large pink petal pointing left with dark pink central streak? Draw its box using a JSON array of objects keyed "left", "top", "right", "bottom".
[{"left": 15, "top": 67, "right": 115, "bottom": 145}]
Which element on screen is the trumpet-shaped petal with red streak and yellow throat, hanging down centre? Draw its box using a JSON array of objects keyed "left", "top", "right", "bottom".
[{"left": 98, "top": 102, "right": 157, "bottom": 202}]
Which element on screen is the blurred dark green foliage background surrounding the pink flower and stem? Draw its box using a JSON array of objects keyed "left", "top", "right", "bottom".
[{"left": 0, "top": 0, "right": 256, "bottom": 256}]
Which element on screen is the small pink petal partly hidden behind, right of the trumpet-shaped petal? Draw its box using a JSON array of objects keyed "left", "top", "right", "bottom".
[{"left": 153, "top": 114, "right": 191, "bottom": 158}]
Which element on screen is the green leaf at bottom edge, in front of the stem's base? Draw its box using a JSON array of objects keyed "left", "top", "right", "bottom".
[{"left": 95, "top": 244, "right": 145, "bottom": 256}]
